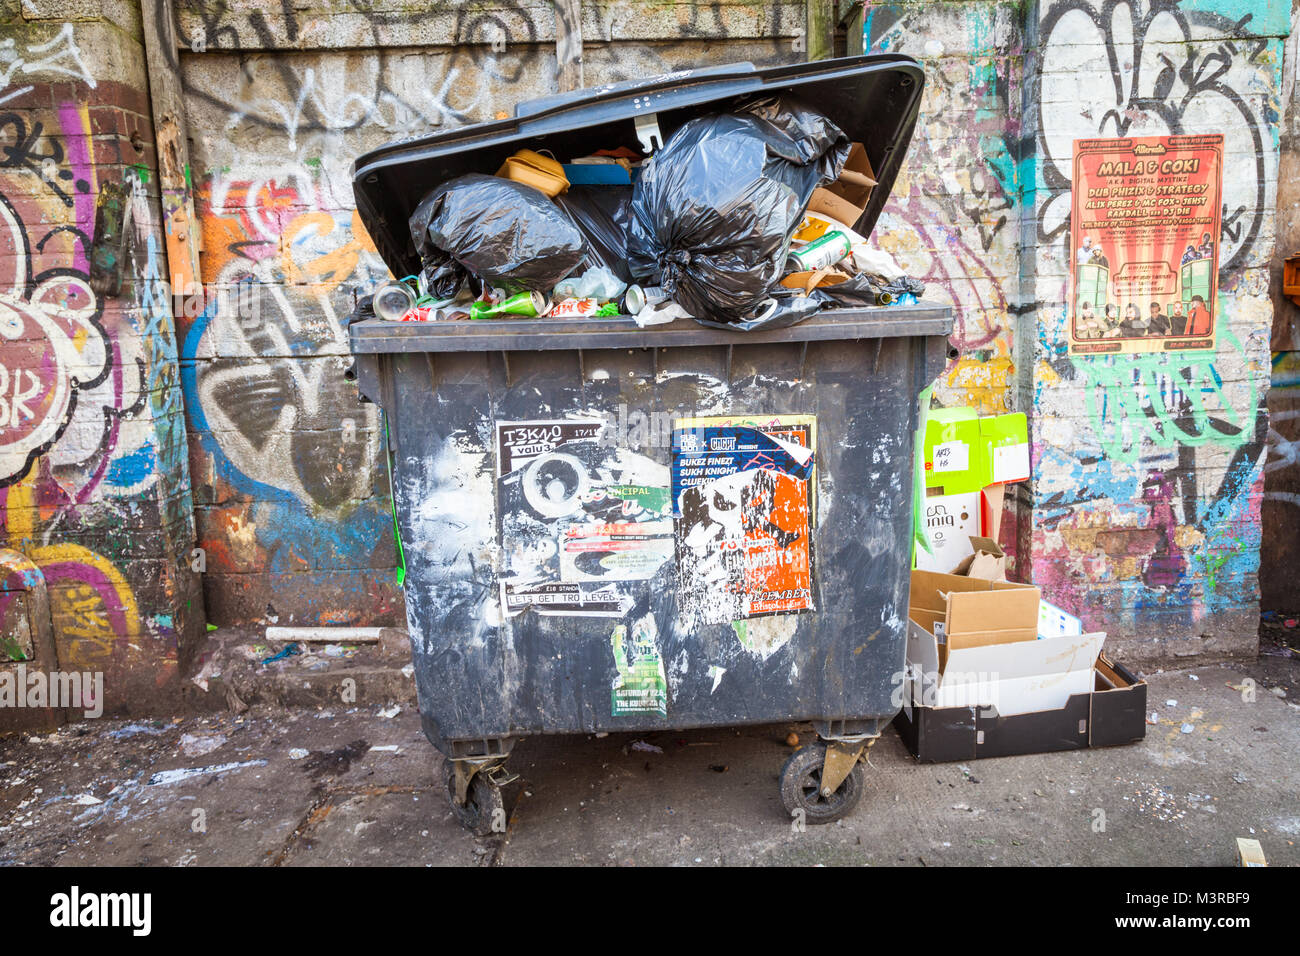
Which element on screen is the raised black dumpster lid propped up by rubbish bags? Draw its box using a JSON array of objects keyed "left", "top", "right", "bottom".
[{"left": 352, "top": 55, "right": 924, "bottom": 276}]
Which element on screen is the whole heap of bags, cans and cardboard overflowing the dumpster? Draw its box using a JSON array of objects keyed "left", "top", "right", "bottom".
[{"left": 377, "top": 95, "right": 924, "bottom": 332}]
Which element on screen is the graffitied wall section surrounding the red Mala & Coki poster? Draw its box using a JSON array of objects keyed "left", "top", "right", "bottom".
[{"left": 1021, "top": 0, "right": 1290, "bottom": 659}]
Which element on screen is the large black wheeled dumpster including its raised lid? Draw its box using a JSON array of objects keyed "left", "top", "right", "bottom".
[{"left": 350, "top": 57, "right": 952, "bottom": 829}]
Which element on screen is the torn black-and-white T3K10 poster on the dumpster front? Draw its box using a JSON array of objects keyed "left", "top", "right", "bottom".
[{"left": 497, "top": 421, "right": 673, "bottom": 618}]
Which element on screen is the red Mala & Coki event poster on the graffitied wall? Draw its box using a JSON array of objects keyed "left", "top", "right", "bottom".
[{"left": 1069, "top": 134, "right": 1223, "bottom": 355}]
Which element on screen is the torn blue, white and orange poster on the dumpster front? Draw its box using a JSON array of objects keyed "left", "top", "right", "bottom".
[{"left": 672, "top": 415, "right": 816, "bottom": 624}]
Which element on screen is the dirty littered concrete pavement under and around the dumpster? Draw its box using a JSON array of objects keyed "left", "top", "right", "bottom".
[{"left": 0, "top": 661, "right": 1300, "bottom": 866}]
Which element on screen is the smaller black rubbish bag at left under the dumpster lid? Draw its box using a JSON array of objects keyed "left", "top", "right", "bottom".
[{"left": 411, "top": 173, "right": 586, "bottom": 298}]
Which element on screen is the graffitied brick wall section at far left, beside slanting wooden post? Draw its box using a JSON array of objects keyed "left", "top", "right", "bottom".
[{"left": 0, "top": 9, "right": 202, "bottom": 713}]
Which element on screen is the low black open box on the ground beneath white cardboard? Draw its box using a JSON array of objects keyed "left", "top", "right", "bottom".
[{"left": 894, "top": 654, "right": 1147, "bottom": 763}]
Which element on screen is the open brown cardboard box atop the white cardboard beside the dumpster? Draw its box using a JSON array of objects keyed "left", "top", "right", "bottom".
[{"left": 907, "top": 571, "right": 1041, "bottom": 658}]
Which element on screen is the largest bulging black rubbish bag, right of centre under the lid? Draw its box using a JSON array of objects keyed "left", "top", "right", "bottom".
[{"left": 628, "top": 96, "right": 849, "bottom": 328}]
